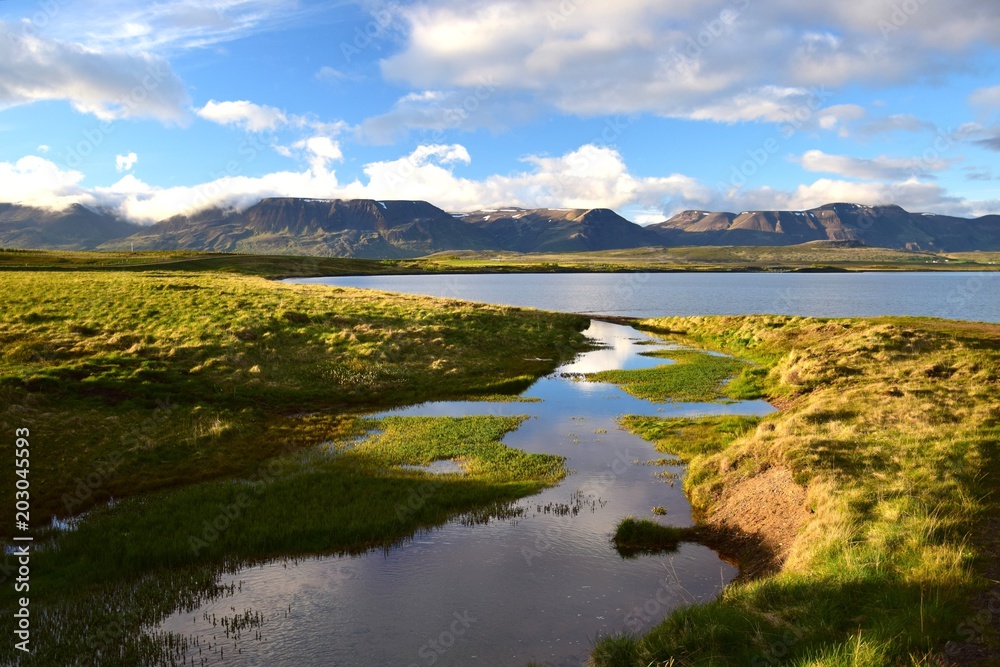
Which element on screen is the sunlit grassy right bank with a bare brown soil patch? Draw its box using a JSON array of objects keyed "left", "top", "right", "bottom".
[{"left": 593, "top": 316, "right": 1000, "bottom": 666}]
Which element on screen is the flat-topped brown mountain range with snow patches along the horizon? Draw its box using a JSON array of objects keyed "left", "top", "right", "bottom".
[{"left": 0, "top": 197, "right": 1000, "bottom": 259}]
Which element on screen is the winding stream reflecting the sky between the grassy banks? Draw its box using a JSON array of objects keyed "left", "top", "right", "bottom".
[{"left": 161, "top": 322, "right": 773, "bottom": 667}]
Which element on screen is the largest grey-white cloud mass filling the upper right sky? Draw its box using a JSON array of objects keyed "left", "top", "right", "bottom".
[{"left": 381, "top": 0, "right": 1000, "bottom": 127}]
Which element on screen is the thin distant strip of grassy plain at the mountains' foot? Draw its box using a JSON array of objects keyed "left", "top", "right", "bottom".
[{"left": 0, "top": 243, "right": 1000, "bottom": 278}]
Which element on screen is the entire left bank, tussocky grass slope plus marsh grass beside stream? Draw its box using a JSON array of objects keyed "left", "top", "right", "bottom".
[{"left": 0, "top": 265, "right": 586, "bottom": 665}]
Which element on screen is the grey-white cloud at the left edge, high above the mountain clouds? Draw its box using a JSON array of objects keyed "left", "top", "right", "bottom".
[{"left": 0, "top": 21, "right": 188, "bottom": 122}]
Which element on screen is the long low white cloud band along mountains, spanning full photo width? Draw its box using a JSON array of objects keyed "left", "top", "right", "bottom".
[{"left": 0, "top": 144, "right": 996, "bottom": 223}]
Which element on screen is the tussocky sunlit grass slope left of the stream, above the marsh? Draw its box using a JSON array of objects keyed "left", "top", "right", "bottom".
[{"left": 0, "top": 271, "right": 586, "bottom": 529}]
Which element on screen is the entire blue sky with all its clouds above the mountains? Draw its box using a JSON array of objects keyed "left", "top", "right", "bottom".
[{"left": 0, "top": 0, "right": 1000, "bottom": 223}]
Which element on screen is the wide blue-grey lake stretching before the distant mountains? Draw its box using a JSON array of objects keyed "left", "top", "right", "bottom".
[{"left": 288, "top": 272, "right": 1000, "bottom": 322}]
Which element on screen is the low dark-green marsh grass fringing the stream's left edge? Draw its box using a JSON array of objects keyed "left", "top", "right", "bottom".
[{"left": 0, "top": 416, "right": 565, "bottom": 665}]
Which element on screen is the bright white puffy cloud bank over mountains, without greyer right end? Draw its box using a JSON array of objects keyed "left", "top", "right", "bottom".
[{"left": 0, "top": 144, "right": 712, "bottom": 223}]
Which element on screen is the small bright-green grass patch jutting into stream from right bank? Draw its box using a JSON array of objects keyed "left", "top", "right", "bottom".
[{"left": 587, "top": 350, "right": 762, "bottom": 402}]
